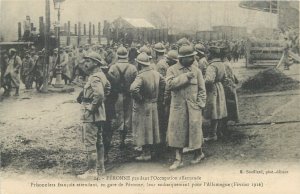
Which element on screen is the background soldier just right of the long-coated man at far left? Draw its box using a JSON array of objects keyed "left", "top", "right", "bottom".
[{"left": 21, "top": 51, "right": 34, "bottom": 89}]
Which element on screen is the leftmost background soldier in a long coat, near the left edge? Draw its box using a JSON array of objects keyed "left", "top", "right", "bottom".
[{"left": 4, "top": 48, "right": 22, "bottom": 96}]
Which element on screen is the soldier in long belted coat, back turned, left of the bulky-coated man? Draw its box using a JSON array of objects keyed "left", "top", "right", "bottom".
[{"left": 130, "top": 52, "right": 165, "bottom": 161}]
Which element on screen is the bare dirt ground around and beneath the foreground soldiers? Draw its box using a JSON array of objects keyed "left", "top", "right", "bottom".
[{"left": 0, "top": 61, "right": 300, "bottom": 180}]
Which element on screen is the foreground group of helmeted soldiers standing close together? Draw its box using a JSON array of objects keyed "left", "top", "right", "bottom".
[{"left": 71, "top": 38, "right": 238, "bottom": 178}]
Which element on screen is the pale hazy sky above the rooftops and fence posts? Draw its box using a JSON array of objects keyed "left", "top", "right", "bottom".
[{"left": 0, "top": 0, "right": 277, "bottom": 41}]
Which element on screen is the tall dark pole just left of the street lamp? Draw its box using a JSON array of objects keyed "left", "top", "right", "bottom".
[{"left": 42, "top": 0, "right": 50, "bottom": 92}]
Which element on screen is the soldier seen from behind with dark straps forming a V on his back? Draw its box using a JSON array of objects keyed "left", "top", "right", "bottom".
[{"left": 108, "top": 46, "right": 137, "bottom": 148}]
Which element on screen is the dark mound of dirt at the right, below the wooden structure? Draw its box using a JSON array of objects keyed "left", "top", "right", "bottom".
[{"left": 240, "top": 68, "right": 299, "bottom": 93}]
